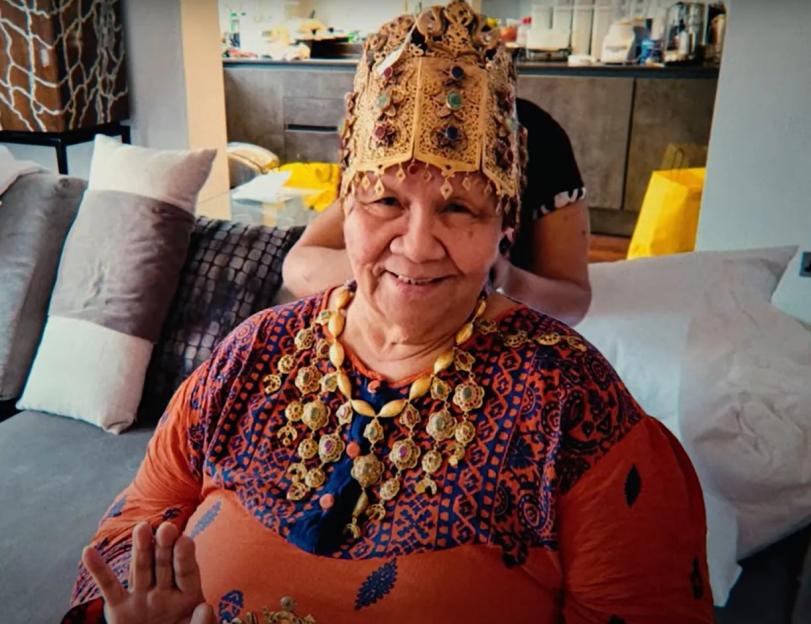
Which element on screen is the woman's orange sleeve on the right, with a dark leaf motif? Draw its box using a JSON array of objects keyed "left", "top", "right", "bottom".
[{"left": 557, "top": 350, "right": 714, "bottom": 624}]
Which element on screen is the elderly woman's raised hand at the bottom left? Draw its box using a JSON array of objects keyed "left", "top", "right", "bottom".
[{"left": 82, "top": 522, "right": 217, "bottom": 624}]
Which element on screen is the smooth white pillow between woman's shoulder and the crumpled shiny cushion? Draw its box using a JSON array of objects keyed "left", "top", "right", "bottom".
[{"left": 577, "top": 247, "right": 796, "bottom": 605}]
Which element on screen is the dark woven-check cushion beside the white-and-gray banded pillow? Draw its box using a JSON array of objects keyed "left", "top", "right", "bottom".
[{"left": 139, "top": 217, "right": 303, "bottom": 422}]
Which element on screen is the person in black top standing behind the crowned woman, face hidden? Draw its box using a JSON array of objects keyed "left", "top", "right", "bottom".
[{"left": 283, "top": 98, "right": 591, "bottom": 325}]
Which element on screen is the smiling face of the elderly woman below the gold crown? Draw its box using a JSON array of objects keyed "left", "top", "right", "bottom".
[{"left": 344, "top": 164, "right": 502, "bottom": 331}]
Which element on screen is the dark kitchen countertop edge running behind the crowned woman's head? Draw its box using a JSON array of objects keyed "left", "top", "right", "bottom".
[{"left": 222, "top": 58, "right": 718, "bottom": 78}]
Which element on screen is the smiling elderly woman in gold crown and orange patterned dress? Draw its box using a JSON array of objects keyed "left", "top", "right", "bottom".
[{"left": 66, "top": 2, "right": 713, "bottom": 624}]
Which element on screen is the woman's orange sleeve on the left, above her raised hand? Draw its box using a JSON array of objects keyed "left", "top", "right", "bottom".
[{"left": 63, "top": 317, "right": 270, "bottom": 624}]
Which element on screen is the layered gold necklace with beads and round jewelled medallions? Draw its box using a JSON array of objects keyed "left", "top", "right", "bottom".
[{"left": 262, "top": 286, "right": 488, "bottom": 540}]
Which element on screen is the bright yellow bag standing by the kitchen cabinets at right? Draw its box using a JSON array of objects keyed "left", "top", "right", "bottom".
[{"left": 628, "top": 167, "right": 706, "bottom": 259}]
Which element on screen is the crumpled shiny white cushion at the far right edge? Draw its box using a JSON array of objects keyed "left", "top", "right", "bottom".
[{"left": 680, "top": 280, "right": 811, "bottom": 558}]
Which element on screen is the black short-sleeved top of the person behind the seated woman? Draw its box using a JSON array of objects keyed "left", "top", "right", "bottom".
[{"left": 511, "top": 98, "right": 586, "bottom": 269}]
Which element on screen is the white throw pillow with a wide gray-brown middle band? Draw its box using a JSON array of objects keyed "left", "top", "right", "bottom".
[{"left": 19, "top": 136, "right": 216, "bottom": 433}]
